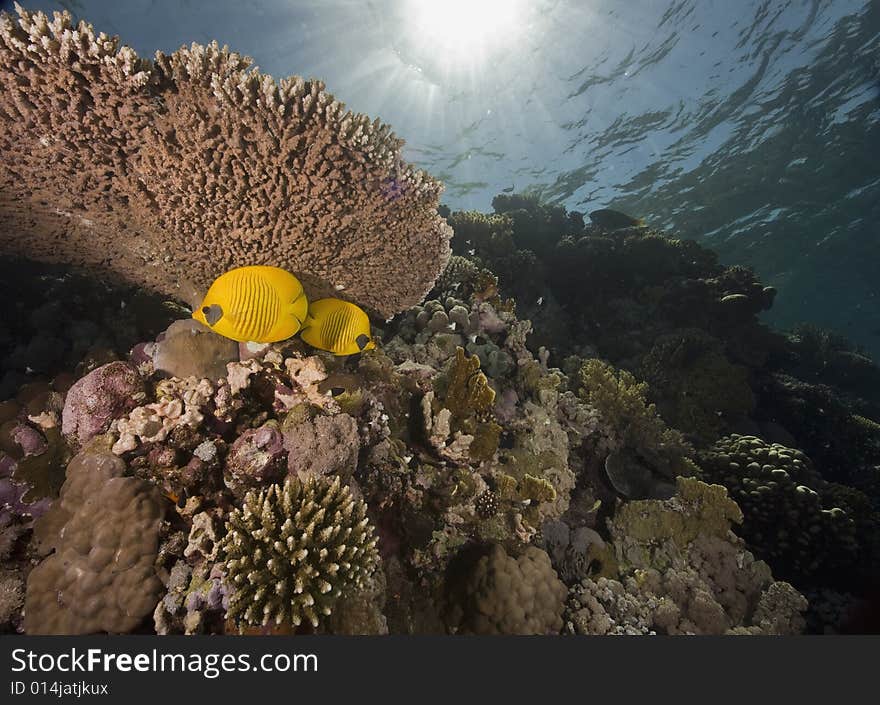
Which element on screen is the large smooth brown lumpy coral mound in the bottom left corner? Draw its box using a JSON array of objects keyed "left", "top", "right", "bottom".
[{"left": 24, "top": 452, "right": 162, "bottom": 634}]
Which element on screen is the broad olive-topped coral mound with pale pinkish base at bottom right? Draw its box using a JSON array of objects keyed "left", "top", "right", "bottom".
[{"left": 566, "top": 478, "right": 807, "bottom": 634}]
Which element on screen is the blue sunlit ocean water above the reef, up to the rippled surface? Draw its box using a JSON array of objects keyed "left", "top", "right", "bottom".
[{"left": 15, "top": 0, "right": 880, "bottom": 358}]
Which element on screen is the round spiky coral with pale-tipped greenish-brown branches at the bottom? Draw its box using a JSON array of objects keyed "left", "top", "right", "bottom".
[{"left": 220, "top": 477, "right": 378, "bottom": 627}]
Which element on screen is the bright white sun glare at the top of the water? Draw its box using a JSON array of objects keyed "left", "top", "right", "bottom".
[{"left": 408, "top": 0, "right": 522, "bottom": 63}]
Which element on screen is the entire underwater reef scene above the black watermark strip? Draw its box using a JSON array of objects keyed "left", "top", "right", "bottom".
[{"left": 0, "top": 0, "right": 880, "bottom": 643}]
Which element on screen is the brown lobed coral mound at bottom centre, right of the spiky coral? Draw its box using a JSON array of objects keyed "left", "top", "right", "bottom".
[{"left": 448, "top": 544, "right": 566, "bottom": 634}]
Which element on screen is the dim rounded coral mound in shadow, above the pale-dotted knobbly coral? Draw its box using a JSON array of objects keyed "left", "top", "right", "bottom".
[{"left": 640, "top": 328, "right": 755, "bottom": 445}]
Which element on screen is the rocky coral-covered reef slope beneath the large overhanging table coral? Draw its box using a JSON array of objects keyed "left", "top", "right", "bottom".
[{"left": 0, "top": 199, "right": 880, "bottom": 634}]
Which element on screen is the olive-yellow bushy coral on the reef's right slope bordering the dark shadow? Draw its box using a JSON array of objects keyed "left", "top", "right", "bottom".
[{"left": 578, "top": 359, "right": 699, "bottom": 498}]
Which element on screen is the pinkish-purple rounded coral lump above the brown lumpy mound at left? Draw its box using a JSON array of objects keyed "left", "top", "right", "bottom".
[{"left": 61, "top": 362, "right": 145, "bottom": 445}]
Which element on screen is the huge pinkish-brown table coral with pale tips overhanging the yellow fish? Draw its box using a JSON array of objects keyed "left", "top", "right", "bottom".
[{"left": 0, "top": 9, "right": 452, "bottom": 316}]
